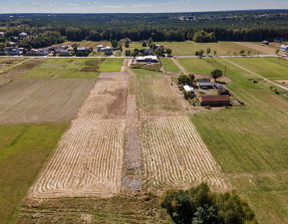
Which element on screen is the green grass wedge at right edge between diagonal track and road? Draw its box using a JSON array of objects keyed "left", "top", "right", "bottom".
[{"left": 229, "top": 58, "right": 288, "bottom": 80}]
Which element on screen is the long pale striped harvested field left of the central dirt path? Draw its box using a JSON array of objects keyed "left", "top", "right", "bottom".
[{"left": 30, "top": 73, "right": 128, "bottom": 198}]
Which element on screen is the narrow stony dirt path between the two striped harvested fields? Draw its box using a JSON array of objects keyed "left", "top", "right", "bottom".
[{"left": 122, "top": 59, "right": 142, "bottom": 192}]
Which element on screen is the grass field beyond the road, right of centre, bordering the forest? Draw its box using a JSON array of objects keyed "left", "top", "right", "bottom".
[{"left": 158, "top": 41, "right": 258, "bottom": 56}]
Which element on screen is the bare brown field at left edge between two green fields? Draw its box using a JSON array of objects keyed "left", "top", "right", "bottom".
[{"left": 0, "top": 79, "right": 95, "bottom": 124}]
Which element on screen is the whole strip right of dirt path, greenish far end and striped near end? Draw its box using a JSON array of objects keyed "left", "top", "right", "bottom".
[{"left": 135, "top": 70, "right": 228, "bottom": 194}]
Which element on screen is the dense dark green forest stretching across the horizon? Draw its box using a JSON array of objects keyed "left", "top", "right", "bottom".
[{"left": 0, "top": 10, "right": 288, "bottom": 47}]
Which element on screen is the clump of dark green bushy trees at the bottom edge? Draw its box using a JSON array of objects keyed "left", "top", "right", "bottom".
[{"left": 160, "top": 183, "right": 258, "bottom": 224}]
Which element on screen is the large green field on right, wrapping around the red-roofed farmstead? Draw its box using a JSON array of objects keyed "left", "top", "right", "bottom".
[{"left": 179, "top": 58, "right": 288, "bottom": 224}]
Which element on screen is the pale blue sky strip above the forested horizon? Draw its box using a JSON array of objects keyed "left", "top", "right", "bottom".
[{"left": 0, "top": 0, "right": 288, "bottom": 14}]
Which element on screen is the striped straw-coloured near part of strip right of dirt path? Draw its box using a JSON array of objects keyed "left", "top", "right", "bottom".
[{"left": 142, "top": 116, "right": 228, "bottom": 192}]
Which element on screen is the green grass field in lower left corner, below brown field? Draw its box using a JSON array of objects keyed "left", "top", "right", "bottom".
[{"left": 0, "top": 123, "right": 69, "bottom": 224}]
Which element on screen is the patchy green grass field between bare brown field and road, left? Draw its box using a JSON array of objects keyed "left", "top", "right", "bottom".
[{"left": 21, "top": 58, "right": 104, "bottom": 79}]
